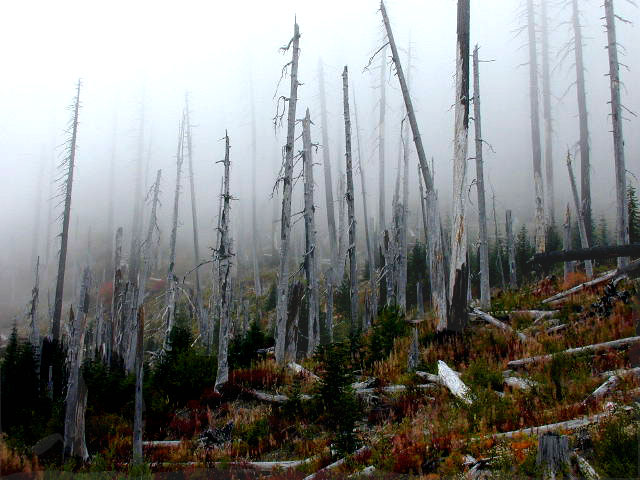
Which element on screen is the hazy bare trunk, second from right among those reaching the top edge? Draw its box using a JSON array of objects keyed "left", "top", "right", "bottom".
[{"left": 571, "top": 0, "right": 593, "bottom": 244}]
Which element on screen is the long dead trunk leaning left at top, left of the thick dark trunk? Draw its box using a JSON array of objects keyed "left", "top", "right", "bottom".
[{"left": 380, "top": 1, "right": 449, "bottom": 330}]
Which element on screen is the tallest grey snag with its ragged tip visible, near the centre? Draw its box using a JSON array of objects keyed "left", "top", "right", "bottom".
[{"left": 275, "top": 19, "right": 300, "bottom": 365}]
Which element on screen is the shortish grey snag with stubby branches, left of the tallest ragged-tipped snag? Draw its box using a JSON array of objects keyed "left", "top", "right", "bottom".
[{"left": 215, "top": 132, "right": 234, "bottom": 392}]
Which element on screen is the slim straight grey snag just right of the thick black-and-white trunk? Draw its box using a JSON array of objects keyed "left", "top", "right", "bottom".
[{"left": 473, "top": 45, "right": 491, "bottom": 310}]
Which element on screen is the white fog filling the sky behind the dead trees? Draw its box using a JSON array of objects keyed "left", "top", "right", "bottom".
[{"left": 0, "top": 0, "right": 640, "bottom": 330}]
